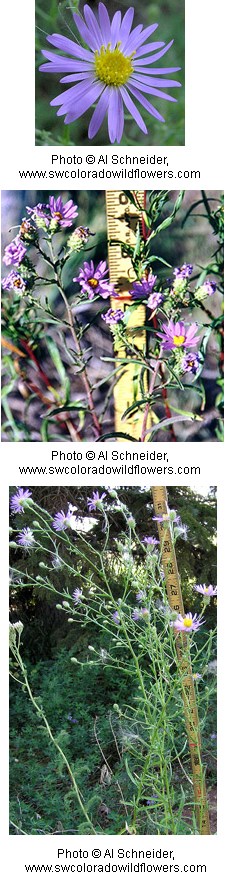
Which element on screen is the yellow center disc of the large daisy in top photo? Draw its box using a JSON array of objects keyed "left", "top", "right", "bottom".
[{"left": 94, "top": 44, "right": 134, "bottom": 86}]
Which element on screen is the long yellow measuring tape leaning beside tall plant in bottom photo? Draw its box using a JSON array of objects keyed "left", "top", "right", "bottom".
[{"left": 152, "top": 486, "right": 210, "bottom": 836}]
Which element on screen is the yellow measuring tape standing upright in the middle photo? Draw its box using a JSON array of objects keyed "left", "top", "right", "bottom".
[{"left": 106, "top": 191, "right": 146, "bottom": 439}]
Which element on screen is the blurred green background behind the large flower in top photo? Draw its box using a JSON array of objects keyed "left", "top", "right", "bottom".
[{"left": 36, "top": 0, "right": 185, "bottom": 147}]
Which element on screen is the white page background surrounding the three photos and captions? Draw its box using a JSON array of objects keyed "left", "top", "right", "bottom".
[{"left": 0, "top": 0, "right": 225, "bottom": 885}]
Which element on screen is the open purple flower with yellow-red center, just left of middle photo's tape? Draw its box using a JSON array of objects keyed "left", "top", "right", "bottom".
[{"left": 73, "top": 261, "right": 116, "bottom": 299}]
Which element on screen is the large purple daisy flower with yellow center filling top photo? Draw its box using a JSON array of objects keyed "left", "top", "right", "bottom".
[{"left": 40, "top": 3, "right": 181, "bottom": 144}]
